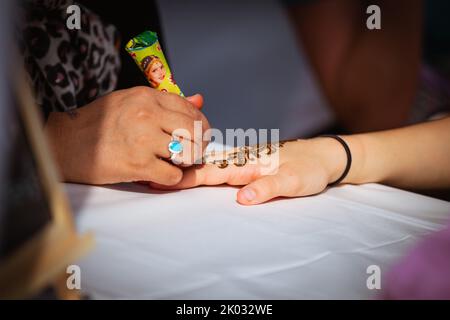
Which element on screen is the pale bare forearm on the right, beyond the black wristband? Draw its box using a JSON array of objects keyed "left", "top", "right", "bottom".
[{"left": 342, "top": 118, "right": 450, "bottom": 189}]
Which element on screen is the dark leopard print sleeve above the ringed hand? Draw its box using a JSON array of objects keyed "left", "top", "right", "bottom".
[{"left": 17, "top": 0, "right": 120, "bottom": 117}]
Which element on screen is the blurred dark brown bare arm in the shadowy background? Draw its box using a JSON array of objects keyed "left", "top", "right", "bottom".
[{"left": 290, "top": 0, "right": 422, "bottom": 132}]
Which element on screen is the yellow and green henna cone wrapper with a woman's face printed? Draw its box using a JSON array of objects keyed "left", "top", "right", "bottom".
[{"left": 125, "top": 31, "right": 184, "bottom": 97}]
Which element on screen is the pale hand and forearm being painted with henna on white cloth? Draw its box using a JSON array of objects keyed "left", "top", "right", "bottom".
[{"left": 151, "top": 118, "right": 450, "bottom": 205}]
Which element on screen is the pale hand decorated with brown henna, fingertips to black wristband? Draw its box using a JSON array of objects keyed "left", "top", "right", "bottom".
[{"left": 151, "top": 138, "right": 346, "bottom": 205}]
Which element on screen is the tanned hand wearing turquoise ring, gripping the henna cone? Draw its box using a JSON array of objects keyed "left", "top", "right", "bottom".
[{"left": 45, "top": 87, "right": 209, "bottom": 185}]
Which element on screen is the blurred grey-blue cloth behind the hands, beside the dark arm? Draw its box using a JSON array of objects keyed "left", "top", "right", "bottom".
[{"left": 157, "top": 0, "right": 334, "bottom": 143}]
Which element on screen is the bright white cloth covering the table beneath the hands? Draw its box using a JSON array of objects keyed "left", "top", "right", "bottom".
[{"left": 66, "top": 184, "right": 450, "bottom": 299}]
